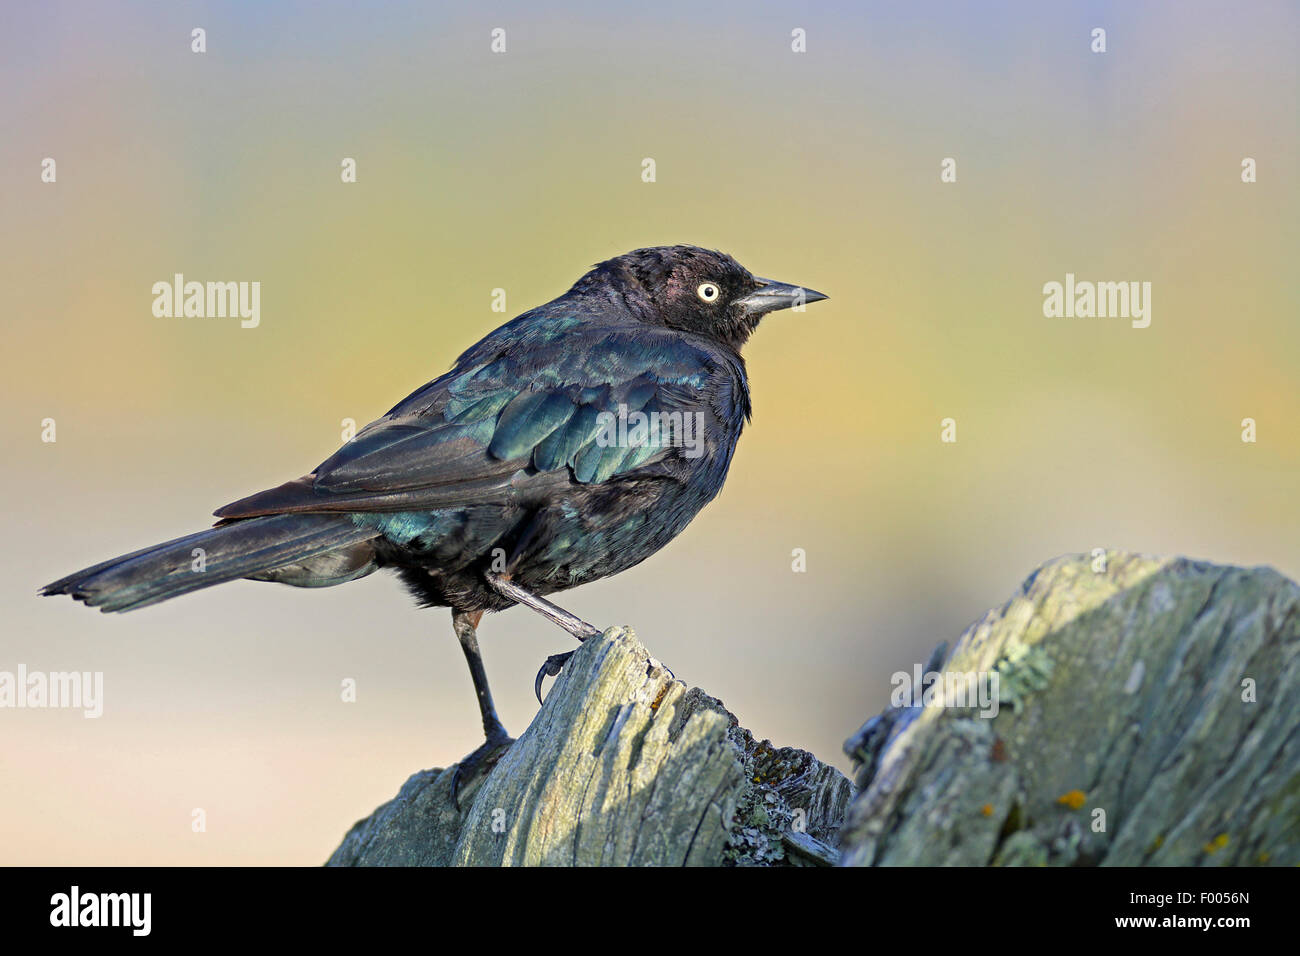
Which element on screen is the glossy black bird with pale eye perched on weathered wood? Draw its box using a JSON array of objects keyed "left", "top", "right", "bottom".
[{"left": 40, "top": 245, "right": 827, "bottom": 805}]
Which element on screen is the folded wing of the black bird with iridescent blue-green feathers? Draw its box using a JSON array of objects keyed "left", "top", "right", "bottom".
[{"left": 216, "top": 326, "right": 736, "bottom": 518}]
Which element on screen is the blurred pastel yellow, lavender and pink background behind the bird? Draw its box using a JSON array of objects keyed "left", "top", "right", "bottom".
[{"left": 0, "top": 3, "right": 1300, "bottom": 864}]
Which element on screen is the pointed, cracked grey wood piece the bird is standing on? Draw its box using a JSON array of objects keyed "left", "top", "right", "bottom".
[{"left": 329, "top": 628, "right": 852, "bottom": 866}]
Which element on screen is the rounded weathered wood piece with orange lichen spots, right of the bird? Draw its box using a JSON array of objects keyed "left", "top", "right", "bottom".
[{"left": 842, "top": 553, "right": 1300, "bottom": 866}]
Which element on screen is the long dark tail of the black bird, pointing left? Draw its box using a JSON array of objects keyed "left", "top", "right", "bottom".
[{"left": 40, "top": 514, "right": 377, "bottom": 611}]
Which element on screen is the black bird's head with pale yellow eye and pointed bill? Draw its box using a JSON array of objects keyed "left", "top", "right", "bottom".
[{"left": 575, "top": 246, "right": 827, "bottom": 350}]
